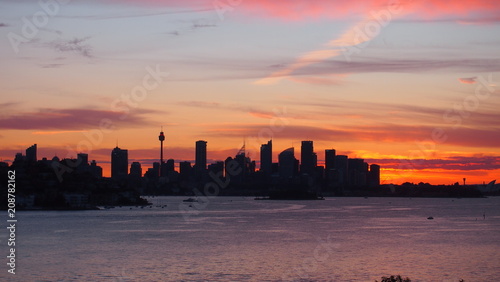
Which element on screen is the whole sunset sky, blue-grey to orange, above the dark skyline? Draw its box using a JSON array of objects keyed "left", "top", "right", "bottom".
[{"left": 0, "top": 0, "right": 500, "bottom": 184}]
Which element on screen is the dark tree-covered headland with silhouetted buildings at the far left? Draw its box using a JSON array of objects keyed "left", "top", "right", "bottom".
[{"left": 0, "top": 144, "right": 147, "bottom": 209}]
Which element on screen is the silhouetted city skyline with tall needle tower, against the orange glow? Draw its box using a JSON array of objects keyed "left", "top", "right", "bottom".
[{"left": 112, "top": 131, "right": 380, "bottom": 195}]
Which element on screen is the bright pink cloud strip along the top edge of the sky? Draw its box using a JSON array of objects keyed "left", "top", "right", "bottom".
[{"left": 108, "top": 0, "right": 500, "bottom": 20}]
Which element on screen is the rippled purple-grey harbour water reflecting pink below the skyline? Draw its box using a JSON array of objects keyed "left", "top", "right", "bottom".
[{"left": 0, "top": 197, "right": 500, "bottom": 281}]
